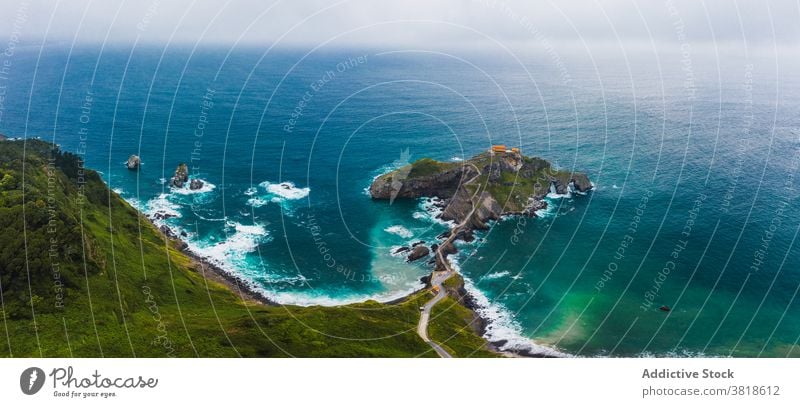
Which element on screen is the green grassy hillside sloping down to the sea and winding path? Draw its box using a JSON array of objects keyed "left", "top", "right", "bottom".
[{"left": 0, "top": 140, "right": 486, "bottom": 357}]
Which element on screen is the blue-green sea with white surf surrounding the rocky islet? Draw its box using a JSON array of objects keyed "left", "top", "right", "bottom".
[{"left": 0, "top": 44, "right": 800, "bottom": 356}]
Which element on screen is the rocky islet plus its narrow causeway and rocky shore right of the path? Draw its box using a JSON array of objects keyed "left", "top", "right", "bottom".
[{"left": 369, "top": 151, "right": 593, "bottom": 358}]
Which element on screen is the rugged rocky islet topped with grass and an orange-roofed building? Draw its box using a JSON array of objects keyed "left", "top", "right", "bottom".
[{"left": 369, "top": 151, "right": 592, "bottom": 233}]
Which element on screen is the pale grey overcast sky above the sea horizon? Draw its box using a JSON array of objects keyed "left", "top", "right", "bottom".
[{"left": 0, "top": 0, "right": 800, "bottom": 48}]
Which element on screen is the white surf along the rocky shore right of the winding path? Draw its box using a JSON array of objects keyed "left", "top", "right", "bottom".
[{"left": 464, "top": 277, "right": 571, "bottom": 357}]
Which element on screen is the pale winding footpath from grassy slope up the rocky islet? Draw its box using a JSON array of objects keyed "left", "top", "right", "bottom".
[{"left": 417, "top": 163, "right": 481, "bottom": 358}]
